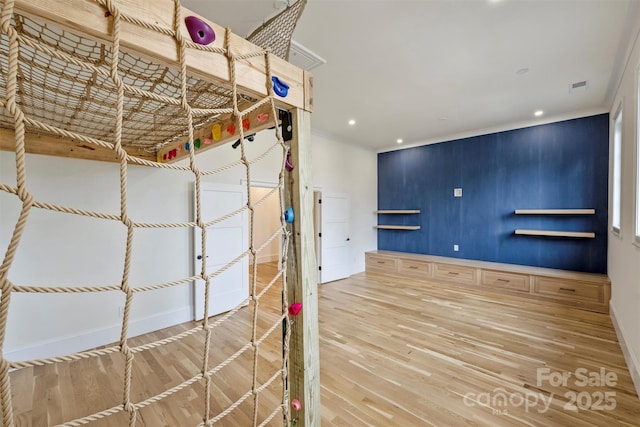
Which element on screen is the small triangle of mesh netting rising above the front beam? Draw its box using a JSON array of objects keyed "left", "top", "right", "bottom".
[{"left": 247, "top": 0, "right": 307, "bottom": 61}]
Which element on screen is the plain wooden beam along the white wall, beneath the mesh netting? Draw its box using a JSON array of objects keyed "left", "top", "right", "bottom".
[{"left": 0, "top": 128, "right": 156, "bottom": 162}]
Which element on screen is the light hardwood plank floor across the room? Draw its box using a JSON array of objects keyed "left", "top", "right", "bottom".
[{"left": 5, "top": 264, "right": 640, "bottom": 427}]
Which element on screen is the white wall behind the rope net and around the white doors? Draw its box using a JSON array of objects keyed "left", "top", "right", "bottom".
[{"left": 0, "top": 127, "right": 377, "bottom": 360}]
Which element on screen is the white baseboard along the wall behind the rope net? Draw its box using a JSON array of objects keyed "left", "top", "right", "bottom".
[{"left": 4, "top": 307, "right": 193, "bottom": 362}]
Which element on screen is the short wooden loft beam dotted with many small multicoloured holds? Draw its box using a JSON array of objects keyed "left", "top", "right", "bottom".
[{"left": 154, "top": 102, "right": 279, "bottom": 163}]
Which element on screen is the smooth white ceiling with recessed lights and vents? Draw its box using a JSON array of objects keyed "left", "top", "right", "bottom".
[{"left": 183, "top": 0, "right": 640, "bottom": 150}]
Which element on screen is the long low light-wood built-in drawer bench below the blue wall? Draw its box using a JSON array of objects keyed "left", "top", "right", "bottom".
[{"left": 365, "top": 251, "right": 611, "bottom": 313}]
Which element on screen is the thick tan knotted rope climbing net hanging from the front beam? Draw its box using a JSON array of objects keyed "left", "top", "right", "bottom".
[{"left": 0, "top": 0, "right": 291, "bottom": 427}]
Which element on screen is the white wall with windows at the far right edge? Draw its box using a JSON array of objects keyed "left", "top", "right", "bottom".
[{"left": 608, "top": 25, "right": 640, "bottom": 395}]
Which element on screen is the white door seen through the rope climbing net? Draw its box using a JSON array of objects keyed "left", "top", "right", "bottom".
[{"left": 194, "top": 183, "right": 249, "bottom": 320}]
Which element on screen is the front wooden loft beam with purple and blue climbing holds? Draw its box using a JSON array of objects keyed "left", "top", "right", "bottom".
[{"left": 15, "top": 0, "right": 313, "bottom": 111}]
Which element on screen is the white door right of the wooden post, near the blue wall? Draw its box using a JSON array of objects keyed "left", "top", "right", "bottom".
[{"left": 319, "top": 192, "right": 351, "bottom": 283}]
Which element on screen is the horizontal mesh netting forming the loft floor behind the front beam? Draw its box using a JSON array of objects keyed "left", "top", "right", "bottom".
[{"left": 0, "top": 15, "right": 254, "bottom": 152}]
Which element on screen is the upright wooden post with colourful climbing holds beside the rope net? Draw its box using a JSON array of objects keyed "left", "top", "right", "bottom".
[{"left": 285, "top": 109, "right": 320, "bottom": 427}]
